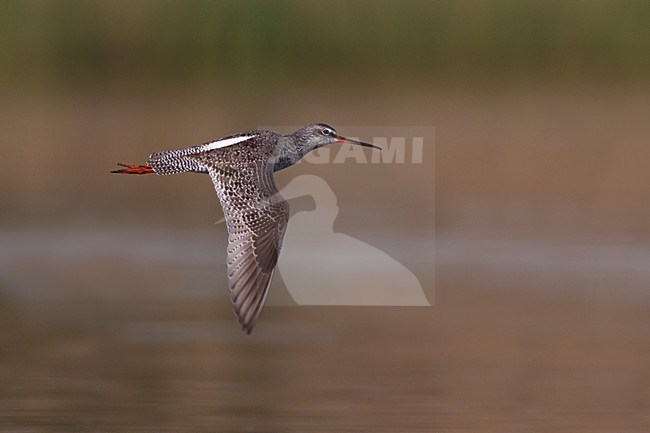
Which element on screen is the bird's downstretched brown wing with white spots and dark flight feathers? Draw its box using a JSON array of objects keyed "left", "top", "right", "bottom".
[{"left": 208, "top": 161, "right": 289, "bottom": 334}]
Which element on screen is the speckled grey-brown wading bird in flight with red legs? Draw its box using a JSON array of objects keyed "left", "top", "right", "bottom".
[{"left": 112, "top": 123, "right": 381, "bottom": 334}]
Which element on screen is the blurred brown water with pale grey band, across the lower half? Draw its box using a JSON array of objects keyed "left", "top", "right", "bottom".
[{"left": 0, "top": 228, "right": 650, "bottom": 432}]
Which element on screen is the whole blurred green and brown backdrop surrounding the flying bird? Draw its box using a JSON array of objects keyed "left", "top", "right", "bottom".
[{"left": 0, "top": 0, "right": 650, "bottom": 432}]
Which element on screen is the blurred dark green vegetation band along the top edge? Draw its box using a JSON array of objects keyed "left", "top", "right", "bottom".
[{"left": 0, "top": 0, "right": 650, "bottom": 93}]
